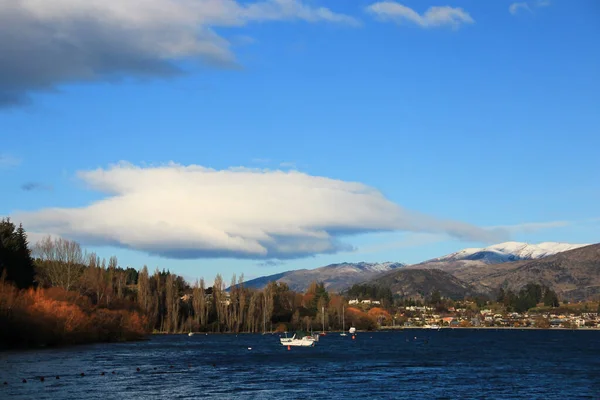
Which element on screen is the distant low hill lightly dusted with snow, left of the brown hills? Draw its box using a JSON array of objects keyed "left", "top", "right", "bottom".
[{"left": 237, "top": 262, "right": 405, "bottom": 292}]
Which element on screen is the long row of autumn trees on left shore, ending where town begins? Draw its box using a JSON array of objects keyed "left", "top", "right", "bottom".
[{"left": 0, "top": 220, "right": 381, "bottom": 344}]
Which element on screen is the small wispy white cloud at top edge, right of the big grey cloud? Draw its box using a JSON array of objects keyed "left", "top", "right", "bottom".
[{"left": 367, "top": 1, "right": 475, "bottom": 28}]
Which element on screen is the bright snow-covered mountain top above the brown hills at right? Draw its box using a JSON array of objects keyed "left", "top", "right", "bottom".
[{"left": 427, "top": 242, "right": 587, "bottom": 264}]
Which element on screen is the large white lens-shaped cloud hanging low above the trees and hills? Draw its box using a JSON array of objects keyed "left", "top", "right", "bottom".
[{"left": 13, "top": 163, "right": 506, "bottom": 259}]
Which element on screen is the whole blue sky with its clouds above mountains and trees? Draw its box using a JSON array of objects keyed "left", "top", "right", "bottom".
[{"left": 0, "top": 0, "right": 600, "bottom": 280}]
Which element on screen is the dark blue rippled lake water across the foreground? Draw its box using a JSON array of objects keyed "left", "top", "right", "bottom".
[{"left": 0, "top": 329, "right": 600, "bottom": 399}]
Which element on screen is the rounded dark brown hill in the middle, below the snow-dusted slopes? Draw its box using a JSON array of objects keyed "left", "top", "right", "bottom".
[{"left": 364, "top": 268, "right": 476, "bottom": 299}]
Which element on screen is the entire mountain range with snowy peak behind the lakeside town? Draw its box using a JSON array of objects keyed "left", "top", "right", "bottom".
[{"left": 237, "top": 242, "right": 600, "bottom": 300}]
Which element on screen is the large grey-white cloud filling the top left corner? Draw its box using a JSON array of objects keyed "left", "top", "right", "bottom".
[{"left": 0, "top": 0, "right": 358, "bottom": 105}]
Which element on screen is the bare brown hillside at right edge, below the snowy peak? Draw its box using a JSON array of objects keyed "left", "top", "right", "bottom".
[{"left": 453, "top": 244, "right": 600, "bottom": 301}]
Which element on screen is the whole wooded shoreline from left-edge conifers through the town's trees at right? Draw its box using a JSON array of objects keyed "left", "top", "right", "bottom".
[{"left": 0, "top": 219, "right": 580, "bottom": 348}]
